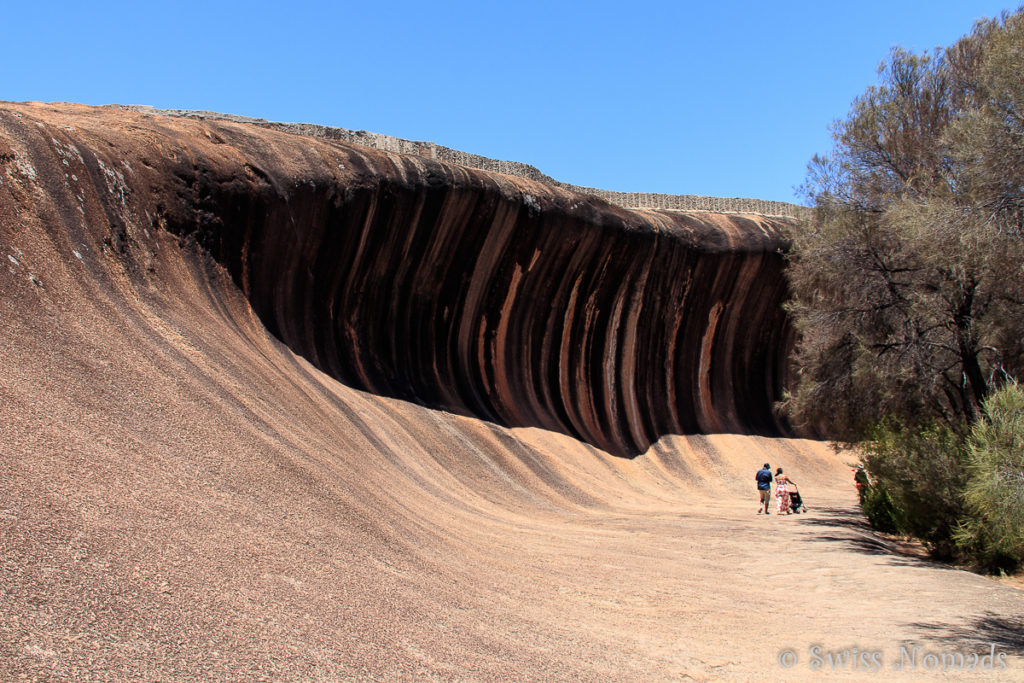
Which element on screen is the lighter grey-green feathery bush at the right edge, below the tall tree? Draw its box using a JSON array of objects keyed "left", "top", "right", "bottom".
[{"left": 956, "top": 383, "right": 1024, "bottom": 569}]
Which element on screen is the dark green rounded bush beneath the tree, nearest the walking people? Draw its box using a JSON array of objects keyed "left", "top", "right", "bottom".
[{"left": 863, "top": 423, "right": 967, "bottom": 559}]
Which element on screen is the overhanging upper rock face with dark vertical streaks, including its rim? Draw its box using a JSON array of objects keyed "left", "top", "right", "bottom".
[{"left": 0, "top": 104, "right": 793, "bottom": 455}]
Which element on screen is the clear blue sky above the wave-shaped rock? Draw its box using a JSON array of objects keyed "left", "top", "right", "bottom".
[{"left": 0, "top": 0, "right": 1017, "bottom": 201}]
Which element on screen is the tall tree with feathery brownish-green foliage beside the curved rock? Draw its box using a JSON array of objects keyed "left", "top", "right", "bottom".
[{"left": 783, "top": 8, "right": 1024, "bottom": 440}]
